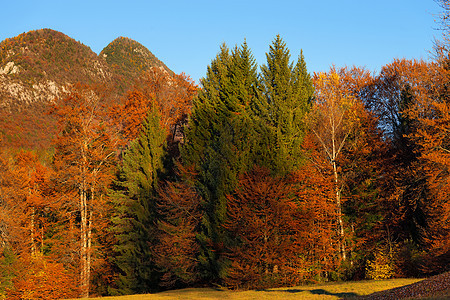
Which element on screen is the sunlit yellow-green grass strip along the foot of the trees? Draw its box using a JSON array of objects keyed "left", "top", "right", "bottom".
[{"left": 86, "top": 279, "right": 420, "bottom": 300}]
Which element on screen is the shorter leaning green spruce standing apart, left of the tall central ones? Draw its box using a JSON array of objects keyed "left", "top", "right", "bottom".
[{"left": 110, "top": 108, "right": 166, "bottom": 294}]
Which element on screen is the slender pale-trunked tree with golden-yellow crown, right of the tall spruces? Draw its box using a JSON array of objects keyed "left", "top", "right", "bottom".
[{"left": 309, "top": 68, "right": 371, "bottom": 261}]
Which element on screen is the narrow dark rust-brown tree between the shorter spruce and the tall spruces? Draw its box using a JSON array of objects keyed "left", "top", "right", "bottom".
[{"left": 152, "top": 165, "right": 201, "bottom": 287}]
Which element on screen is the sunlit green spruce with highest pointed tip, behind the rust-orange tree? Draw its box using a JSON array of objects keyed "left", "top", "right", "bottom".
[{"left": 258, "top": 35, "right": 314, "bottom": 174}]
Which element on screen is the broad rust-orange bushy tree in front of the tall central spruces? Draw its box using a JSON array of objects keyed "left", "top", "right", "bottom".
[{"left": 224, "top": 166, "right": 336, "bottom": 289}]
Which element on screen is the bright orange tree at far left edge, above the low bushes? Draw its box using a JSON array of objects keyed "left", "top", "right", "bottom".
[{"left": 1, "top": 151, "right": 53, "bottom": 255}]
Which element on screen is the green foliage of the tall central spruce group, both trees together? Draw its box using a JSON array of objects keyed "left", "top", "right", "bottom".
[{"left": 182, "top": 37, "right": 314, "bottom": 278}]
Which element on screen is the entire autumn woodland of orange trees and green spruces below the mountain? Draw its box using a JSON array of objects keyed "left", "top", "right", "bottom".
[{"left": 0, "top": 1, "right": 450, "bottom": 299}]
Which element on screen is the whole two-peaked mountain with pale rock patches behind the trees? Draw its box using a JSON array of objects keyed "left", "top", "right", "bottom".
[{"left": 0, "top": 29, "right": 173, "bottom": 148}]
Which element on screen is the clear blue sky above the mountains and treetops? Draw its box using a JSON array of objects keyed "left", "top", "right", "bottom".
[{"left": 0, "top": 0, "right": 440, "bottom": 82}]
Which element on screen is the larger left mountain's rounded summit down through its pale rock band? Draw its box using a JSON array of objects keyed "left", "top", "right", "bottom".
[{"left": 0, "top": 29, "right": 112, "bottom": 110}]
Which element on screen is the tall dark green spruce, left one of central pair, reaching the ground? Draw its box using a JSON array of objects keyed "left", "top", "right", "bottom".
[{"left": 182, "top": 43, "right": 258, "bottom": 280}]
